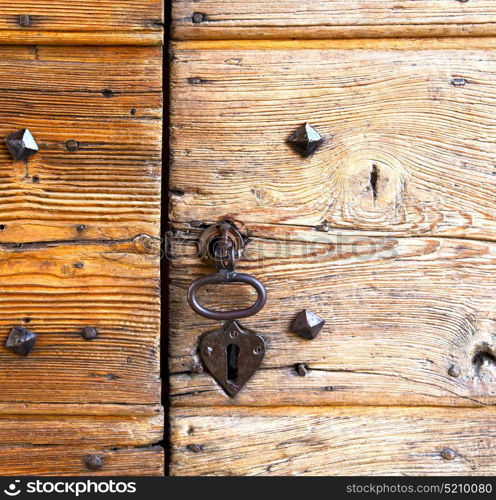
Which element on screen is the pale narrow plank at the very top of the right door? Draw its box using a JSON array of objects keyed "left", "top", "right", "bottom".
[{"left": 172, "top": 0, "right": 496, "bottom": 40}]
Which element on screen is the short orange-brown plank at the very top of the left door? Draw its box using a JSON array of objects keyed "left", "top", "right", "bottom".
[{"left": 0, "top": 0, "right": 163, "bottom": 45}]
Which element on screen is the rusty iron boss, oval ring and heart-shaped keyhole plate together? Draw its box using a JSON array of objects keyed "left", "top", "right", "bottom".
[{"left": 188, "top": 223, "right": 267, "bottom": 397}]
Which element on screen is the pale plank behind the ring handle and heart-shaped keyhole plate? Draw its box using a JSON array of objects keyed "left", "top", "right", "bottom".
[{"left": 170, "top": 225, "right": 496, "bottom": 406}]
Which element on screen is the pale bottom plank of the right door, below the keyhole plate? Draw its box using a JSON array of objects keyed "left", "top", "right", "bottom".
[{"left": 171, "top": 407, "right": 496, "bottom": 476}]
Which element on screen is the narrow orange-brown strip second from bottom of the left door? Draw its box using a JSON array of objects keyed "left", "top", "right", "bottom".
[{"left": 0, "top": 414, "right": 164, "bottom": 448}]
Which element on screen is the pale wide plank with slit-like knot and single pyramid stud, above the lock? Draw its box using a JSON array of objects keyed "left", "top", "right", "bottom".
[{"left": 170, "top": 43, "right": 496, "bottom": 239}]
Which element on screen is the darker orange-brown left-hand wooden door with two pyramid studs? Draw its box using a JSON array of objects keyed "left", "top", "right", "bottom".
[{"left": 0, "top": 0, "right": 163, "bottom": 475}]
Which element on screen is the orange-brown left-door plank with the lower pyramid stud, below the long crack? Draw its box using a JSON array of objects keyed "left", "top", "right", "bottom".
[{"left": 0, "top": 236, "right": 160, "bottom": 404}]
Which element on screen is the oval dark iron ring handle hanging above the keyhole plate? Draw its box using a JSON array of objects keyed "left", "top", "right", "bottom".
[{"left": 188, "top": 271, "right": 267, "bottom": 320}]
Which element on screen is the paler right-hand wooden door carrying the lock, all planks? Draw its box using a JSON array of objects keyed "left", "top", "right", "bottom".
[{"left": 169, "top": 0, "right": 496, "bottom": 476}]
